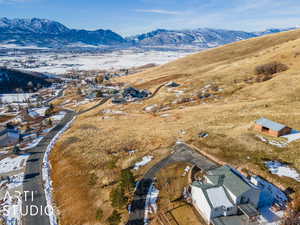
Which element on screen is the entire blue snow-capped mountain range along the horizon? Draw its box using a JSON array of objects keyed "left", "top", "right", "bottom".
[{"left": 0, "top": 18, "right": 295, "bottom": 48}]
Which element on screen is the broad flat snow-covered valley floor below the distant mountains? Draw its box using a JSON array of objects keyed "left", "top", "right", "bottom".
[{"left": 0, "top": 50, "right": 191, "bottom": 74}]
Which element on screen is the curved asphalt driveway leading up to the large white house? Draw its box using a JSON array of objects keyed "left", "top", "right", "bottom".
[{"left": 127, "top": 144, "right": 217, "bottom": 225}]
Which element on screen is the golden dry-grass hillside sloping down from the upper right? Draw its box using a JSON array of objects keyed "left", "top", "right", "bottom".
[{"left": 52, "top": 30, "right": 300, "bottom": 224}]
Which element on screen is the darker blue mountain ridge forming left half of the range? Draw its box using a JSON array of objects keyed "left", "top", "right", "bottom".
[{"left": 0, "top": 18, "right": 126, "bottom": 48}]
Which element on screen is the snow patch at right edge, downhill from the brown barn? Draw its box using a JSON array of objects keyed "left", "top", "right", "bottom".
[{"left": 265, "top": 161, "right": 300, "bottom": 182}]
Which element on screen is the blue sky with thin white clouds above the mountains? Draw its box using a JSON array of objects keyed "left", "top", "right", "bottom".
[{"left": 0, "top": 0, "right": 300, "bottom": 36}]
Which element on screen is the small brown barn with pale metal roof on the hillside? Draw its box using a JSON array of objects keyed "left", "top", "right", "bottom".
[{"left": 254, "top": 118, "right": 292, "bottom": 137}]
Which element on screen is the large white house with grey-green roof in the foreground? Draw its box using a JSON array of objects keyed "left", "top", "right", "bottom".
[{"left": 191, "top": 166, "right": 261, "bottom": 225}]
